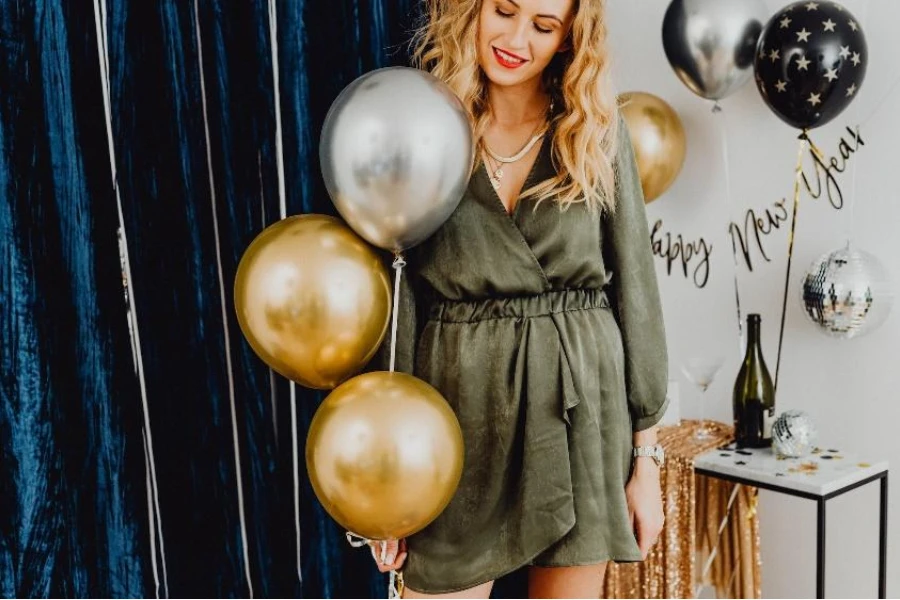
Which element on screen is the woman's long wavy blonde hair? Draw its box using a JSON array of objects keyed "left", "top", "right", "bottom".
[{"left": 412, "top": 0, "right": 619, "bottom": 212}]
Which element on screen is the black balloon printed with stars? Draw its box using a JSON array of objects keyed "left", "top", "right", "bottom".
[{"left": 754, "top": 2, "right": 869, "bottom": 130}]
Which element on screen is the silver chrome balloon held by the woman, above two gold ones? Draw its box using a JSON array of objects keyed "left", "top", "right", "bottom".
[{"left": 319, "top": 67, "right": 474, "bottom": 252}]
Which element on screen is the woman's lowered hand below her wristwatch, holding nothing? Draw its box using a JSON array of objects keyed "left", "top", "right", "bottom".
[{"left": 625, "top": 456, "right": 665, "bottom": 559}]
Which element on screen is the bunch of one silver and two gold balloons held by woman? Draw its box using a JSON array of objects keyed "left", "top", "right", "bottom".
[{"left": 234, "top": 67, "right": 473, "bottom": 564}]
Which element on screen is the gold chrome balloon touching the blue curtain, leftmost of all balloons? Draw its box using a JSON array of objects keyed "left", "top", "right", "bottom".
[{"left": 234, "top": 215, "right": 391, "bottom": 389}]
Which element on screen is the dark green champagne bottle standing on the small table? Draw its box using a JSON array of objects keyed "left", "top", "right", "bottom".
[{"left": 734, "top": 314, "right": 775, "bottom": 448}]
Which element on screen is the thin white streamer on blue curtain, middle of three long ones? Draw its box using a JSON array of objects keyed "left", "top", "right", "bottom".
[{"left": 194, "top": 0, "right": 253, "bottom": 598}]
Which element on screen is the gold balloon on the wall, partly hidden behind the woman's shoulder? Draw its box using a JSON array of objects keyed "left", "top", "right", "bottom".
[{"left": 619, "top": 92, "right": 687, "bottom": 204}]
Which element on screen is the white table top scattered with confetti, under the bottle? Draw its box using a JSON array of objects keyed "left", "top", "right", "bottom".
[{"left": 694, "top": 443, "right": 888, "bottom": 496}]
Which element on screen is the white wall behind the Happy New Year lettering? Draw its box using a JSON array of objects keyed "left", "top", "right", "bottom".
[{"left": 608, "top": 0, "right": 900, "bottom": 597}]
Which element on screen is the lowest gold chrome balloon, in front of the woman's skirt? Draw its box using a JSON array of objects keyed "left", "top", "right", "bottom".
[{"left": 306, "top": 371, "right": 464, "bottom": 540}]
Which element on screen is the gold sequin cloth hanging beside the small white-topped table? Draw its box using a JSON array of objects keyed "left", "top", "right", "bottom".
[{"left": 604, "top": 420, "right": 761, "bottom": 598}]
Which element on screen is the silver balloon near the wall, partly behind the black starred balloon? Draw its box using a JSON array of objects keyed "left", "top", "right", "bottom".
[{"left": 663, "top": 0, "right": 769, "bottom": 100}]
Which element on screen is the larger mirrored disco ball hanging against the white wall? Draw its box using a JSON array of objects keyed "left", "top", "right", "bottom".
[{"left": 801, "top": 244, "right": 894, "bottom": 339}]
